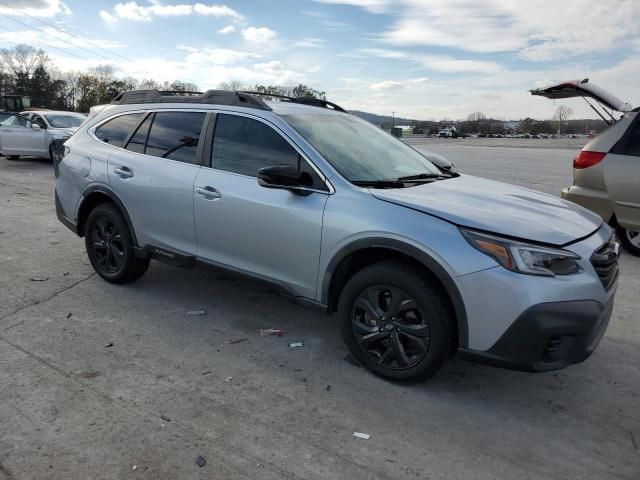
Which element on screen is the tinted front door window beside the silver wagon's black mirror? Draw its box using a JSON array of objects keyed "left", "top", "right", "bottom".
[{"left": 213, "top": 114, "right": 298, "bottom": 177}]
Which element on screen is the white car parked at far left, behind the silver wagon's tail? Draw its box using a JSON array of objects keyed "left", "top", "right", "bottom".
[{"left": 0, "top": 110, "right": 87, "bottom": 160}]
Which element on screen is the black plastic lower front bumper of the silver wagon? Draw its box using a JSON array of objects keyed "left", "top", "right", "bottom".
[{"left": 460, "top": 295, "right": 613, "bottom": 372}]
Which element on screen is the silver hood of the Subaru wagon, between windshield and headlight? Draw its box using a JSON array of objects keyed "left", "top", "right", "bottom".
[{"left": 370, "top": 175, "right": 602, "bottom": 246}]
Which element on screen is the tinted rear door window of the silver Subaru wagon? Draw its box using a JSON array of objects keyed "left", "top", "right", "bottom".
[{"left": 145, "top": 112, "right": 206, "bottom": 164}]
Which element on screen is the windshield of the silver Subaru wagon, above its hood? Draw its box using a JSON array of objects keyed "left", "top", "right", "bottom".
[{"left": 282, "top": 115, "right": 442, "bottom": 182}]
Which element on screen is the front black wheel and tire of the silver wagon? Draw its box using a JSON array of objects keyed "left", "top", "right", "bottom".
[{"left": 338, "top": 261, "right": 453, "bottom": 381}]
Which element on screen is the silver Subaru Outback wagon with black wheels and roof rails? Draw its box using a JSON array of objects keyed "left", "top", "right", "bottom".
[{"left": 55, "top": 90, "right": 618, "bottom": 380}]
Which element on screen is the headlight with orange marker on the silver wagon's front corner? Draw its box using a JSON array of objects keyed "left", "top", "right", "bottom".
[{"left": 460, "top": 229, "right": 580, "bottom": 277}]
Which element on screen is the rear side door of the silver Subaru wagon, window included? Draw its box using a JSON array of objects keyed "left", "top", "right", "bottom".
[{"left": 102, "top": 110, "right": 207, "bottom": 255}]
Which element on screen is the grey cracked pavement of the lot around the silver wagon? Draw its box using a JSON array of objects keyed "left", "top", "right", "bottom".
[{"left": 0, "top": 147, "right": 640, "bottom": 480}]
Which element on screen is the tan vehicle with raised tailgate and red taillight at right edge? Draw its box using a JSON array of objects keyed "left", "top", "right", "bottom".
[{"left": 531, "top": 79, "right": 640, "bottom": 256}]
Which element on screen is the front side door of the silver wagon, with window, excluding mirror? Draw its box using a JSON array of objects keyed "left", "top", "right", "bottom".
[{"left": 194, "top": 114, "right": 329, "bottom": 298}]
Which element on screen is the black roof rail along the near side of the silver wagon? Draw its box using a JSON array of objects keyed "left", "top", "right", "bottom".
[{"left": 111, "top": 89, "right": 271, "bottom": 110}]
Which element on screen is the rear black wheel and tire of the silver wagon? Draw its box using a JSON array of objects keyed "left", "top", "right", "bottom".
[{"left": 84, "top": 203, "right": 150, "bottom": 283}]
